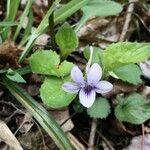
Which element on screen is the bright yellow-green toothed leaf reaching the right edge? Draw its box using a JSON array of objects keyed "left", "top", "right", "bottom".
[{"left": 103, "top": 42, "right": 150, "bottom": 72}]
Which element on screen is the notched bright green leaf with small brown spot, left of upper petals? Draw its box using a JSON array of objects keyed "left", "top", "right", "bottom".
[{"left": 29, "top": 50, "right": 73, "bottom": 77}]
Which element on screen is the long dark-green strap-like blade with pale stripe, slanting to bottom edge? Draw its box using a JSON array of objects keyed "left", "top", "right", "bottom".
[{"left": 3, "top": 77, "right": 73, "bottom": 150}]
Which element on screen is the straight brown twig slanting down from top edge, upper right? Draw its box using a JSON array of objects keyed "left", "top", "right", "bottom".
[{"left": 119, "top": 0, "right": 135, "bottom": 42}]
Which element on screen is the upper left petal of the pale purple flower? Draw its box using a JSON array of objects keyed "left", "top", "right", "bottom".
[{"left": 71, "top": 66, "right": 84, "bottom": 84}]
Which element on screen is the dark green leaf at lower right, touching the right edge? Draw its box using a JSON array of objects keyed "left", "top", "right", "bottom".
[{"left": 115, "top": 93, "right": 150, "bottom": 124}]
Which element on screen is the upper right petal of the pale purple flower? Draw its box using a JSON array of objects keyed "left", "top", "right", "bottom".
[{"left": 87, "top": 63, "right": 102, "bottom": 85}]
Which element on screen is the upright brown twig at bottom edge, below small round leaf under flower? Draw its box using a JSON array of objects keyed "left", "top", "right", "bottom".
[{"left": 88, "top": 119, "right": 97, "bottom": 150}]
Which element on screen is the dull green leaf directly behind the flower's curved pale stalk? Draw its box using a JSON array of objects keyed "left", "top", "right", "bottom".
[{"left": 83, "top": 47, "right": 103, "bottom": 64}]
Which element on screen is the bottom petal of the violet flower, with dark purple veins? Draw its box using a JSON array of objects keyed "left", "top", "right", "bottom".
[{"left": 79, "top": 88, "right": 96, "bottom": 108}]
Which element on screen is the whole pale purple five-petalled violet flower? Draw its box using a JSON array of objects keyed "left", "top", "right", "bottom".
[{"left": 62, "top": 63, "right": 113, "bottom": 108}]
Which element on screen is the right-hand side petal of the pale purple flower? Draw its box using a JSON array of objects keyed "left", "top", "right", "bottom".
[{"left": 95, "top": 81, "right": 113, "bottom": 94}]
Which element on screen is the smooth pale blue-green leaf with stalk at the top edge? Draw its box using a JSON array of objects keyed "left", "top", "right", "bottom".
[{"left": 75, "top": 0, "right": 122, "bottom": 32}]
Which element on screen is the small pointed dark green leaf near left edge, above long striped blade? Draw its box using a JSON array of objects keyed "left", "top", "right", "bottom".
[{"left": 6, "top": 69, "right": 26, "bottom": 83}]
